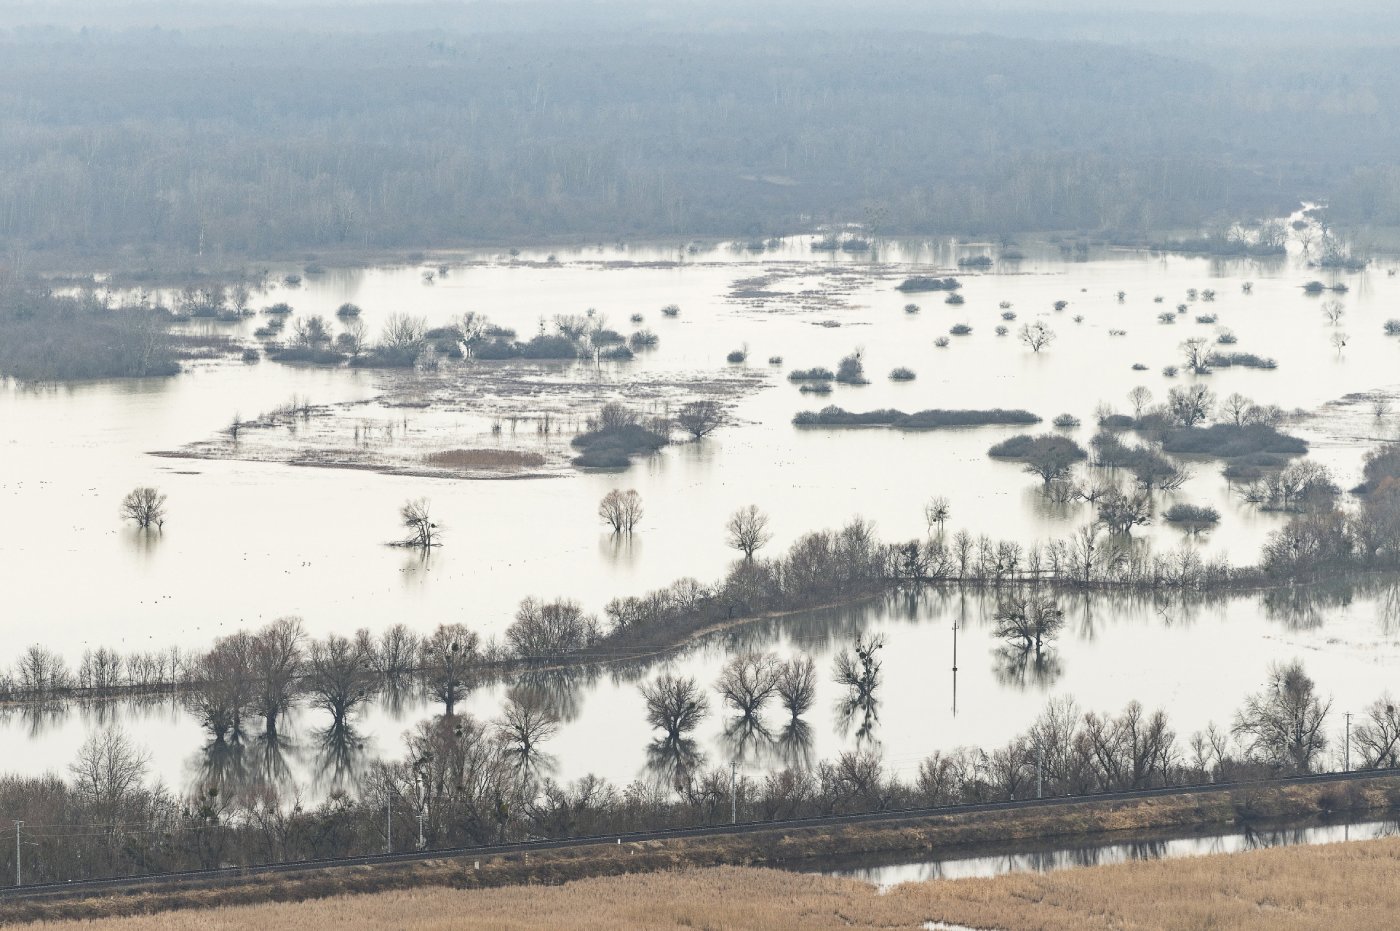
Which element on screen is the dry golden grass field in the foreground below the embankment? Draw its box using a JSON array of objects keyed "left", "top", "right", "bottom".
[{"left": 24, "top": 839, "right": 1400, "bottom": 931}]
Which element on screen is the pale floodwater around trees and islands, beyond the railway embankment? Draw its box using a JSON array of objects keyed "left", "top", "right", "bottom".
[{"left": 0, "top": 231, "right": 1400, "bottom": 794}]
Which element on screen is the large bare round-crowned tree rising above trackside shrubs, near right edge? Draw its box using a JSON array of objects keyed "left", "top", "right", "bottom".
[{"left": 1233, "top": 659, "right": 1331, "bottom": 773}]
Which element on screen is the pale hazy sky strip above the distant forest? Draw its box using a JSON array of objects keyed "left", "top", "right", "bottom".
[{"left": 8, "top": 0, "right": 1400, "bottom": 43}]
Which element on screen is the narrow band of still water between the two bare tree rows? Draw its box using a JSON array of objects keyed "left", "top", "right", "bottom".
[{"left": 0, "top": 580, "right": 1400, "bottom": 798}]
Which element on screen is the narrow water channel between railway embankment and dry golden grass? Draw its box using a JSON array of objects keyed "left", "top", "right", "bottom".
[{"left": 830, "top": 822, "right": 1400, "bottom": 884}]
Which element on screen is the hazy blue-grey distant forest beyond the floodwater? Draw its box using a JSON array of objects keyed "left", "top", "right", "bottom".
[{"left": 0, "top": 26, "right": 1400, "bottom": 259}]
